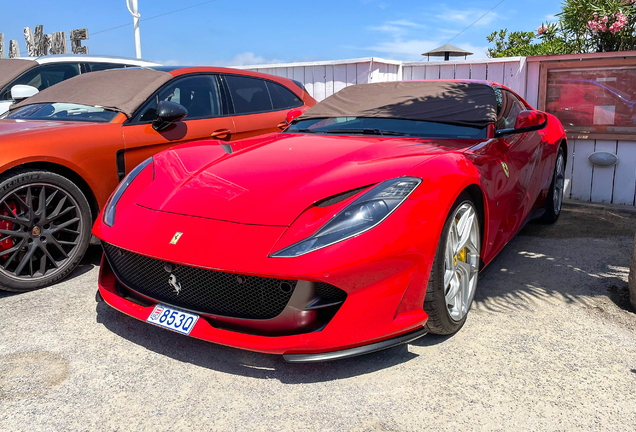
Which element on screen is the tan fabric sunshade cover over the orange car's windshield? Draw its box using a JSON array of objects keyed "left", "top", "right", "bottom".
[{"left": 11, "top": 69, "right": 172, "bottom": 117}]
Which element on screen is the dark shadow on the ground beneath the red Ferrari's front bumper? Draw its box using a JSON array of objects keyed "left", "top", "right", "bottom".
[{"left": 96, "top": 301, "right": 417, "bottom": 384}]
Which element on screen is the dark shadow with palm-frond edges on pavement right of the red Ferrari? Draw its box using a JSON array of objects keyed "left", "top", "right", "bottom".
[{"left": 473, "top": 206, "right": 636, "bottom": 313}]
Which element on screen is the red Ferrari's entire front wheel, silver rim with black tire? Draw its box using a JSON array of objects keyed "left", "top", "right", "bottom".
[{"left": 424, "top": 193, "right": 481, "bottom": 335}]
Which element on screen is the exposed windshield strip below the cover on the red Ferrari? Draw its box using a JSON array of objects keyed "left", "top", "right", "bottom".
[{"left": 286, "top": 117, "right": 486, "bottom": 139}]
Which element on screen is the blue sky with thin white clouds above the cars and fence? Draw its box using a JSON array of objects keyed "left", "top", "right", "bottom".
[{"left": 0, "top": 0, "right": 560, "bottom": 65}]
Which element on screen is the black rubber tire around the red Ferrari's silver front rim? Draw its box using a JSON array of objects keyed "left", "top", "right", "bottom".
[{"left": 424, "top": 192, "right": 481, "bottom": 335}]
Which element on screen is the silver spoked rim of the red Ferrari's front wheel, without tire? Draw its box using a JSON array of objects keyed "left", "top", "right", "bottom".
[{"left": 444, "top": 202, "right": 480, "bottom": 322}]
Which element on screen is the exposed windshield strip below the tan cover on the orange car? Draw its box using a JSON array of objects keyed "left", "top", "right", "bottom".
[{"left": 4, "top": 102, "right": 117, "bottom": 123}]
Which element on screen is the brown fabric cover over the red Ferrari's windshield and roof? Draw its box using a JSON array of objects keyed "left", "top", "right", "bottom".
[{"left": 298, "top": 81, "right": 497, "bottom": 127}]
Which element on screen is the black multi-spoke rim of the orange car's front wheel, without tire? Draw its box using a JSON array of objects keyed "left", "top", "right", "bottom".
[{"left": 0, "top": 183, "right": 84, "bottom": 280}]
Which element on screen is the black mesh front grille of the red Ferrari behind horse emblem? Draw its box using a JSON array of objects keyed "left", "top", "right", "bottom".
[{"left": 102, "top": 243, "right": 300, "bottom": 319}]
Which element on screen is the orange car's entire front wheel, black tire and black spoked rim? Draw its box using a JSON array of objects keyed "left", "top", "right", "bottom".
[{"left": 0, "top": 170, "right": 92, "bottom": 292}]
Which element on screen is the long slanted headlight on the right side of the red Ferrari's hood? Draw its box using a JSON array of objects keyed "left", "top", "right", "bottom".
[{"left": 271, "top": 177, "right": 422, "bottom": 258}]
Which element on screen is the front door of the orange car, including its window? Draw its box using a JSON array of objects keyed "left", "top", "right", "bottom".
[{"left": 123, "top": 74, "right": 235, "bottom": 173}]
